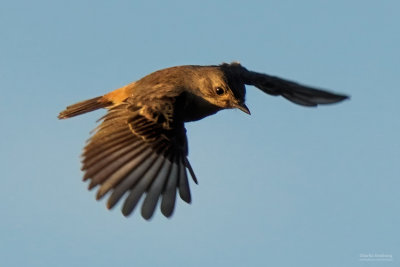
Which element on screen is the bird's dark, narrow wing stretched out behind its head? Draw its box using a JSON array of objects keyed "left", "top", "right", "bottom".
[{"left": 240, "top": 69, "right": 348, "bottom": 107}]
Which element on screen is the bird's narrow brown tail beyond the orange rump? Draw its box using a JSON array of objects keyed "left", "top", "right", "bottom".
[{"left": 58, "top": 96, "right": 112, "bottom": 119}]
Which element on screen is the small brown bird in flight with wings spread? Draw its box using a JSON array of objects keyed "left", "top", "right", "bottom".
[{"left": 58, "top": 63, "right": 348, "bottom": 219}]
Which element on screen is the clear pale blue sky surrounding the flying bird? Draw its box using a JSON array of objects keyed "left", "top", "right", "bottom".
[{"left": 0, "top": 0, "right": 400, "bottom": 267}]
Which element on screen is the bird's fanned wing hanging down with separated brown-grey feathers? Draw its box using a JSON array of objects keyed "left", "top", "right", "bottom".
[{"left": 82, "top": 98, "right": 197, "bottom": 219}]
